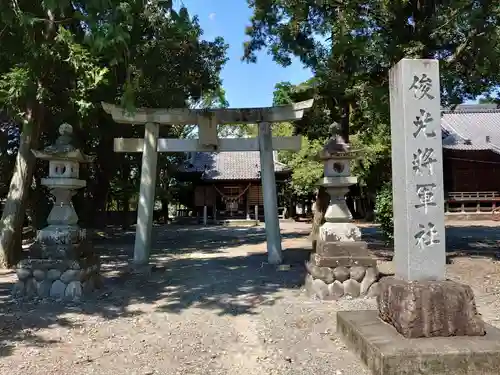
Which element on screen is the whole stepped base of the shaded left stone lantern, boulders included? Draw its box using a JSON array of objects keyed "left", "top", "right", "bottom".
[{"left": 13, "top": 225, "right": 102, "bottom": 301}]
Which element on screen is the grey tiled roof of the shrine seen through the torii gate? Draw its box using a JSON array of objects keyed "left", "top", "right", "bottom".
[{"left": 179, "top": 151, "right": 287, "bottom": 180}]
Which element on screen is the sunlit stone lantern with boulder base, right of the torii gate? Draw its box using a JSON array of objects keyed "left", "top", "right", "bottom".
[{"left": 306, "top": 128, "right": 379, "bottom": 299}]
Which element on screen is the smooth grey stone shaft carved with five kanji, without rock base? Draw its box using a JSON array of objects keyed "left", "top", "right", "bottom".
[{"left": 389, "top": 59, "right": 446, "bottom": 280}]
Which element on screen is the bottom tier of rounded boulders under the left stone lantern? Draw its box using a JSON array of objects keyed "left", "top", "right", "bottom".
[{"left": 13, "top": 259, "right": 102, "bottom": 301}]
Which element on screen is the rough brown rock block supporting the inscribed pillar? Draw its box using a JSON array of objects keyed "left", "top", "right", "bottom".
[{"left": 377, "top": 277, "right": 486, "bottom": 338}]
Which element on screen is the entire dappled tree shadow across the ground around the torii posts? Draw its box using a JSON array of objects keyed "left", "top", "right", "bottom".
[{"left": 0, "top": 227, "right": 309, "bottom": 357}]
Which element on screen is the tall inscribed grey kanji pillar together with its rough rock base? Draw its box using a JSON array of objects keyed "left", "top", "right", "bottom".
[{"left": 379, "top": 59, "right": 485, "bottom": 338}]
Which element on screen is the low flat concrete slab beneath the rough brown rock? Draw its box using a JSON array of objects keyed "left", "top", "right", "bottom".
[{"left": 337, "top": 310, "right": 500, "bottom": 375}]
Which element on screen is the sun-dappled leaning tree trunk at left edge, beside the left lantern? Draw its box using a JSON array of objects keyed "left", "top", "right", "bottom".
[{"left": 0, "top": 121, "right": 40, "bottom": 267}]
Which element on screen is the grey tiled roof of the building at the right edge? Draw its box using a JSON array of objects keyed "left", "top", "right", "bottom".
[{"left": 441, "top": 104, "right": 500, "bottom": 153}]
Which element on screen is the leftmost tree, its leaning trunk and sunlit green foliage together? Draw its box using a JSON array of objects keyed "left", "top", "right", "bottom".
[{"left": 0, "top": 1, "right": 113, "bottom": 265}]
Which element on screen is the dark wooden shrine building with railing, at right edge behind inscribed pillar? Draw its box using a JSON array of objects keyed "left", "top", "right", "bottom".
[{"left": 441, "top": 104, "right": 500, "bottom": 219}]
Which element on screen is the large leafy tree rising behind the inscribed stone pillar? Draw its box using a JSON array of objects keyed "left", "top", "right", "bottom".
[{"left": 244, "top": 0, "right": 500, "bottom": 238}]
